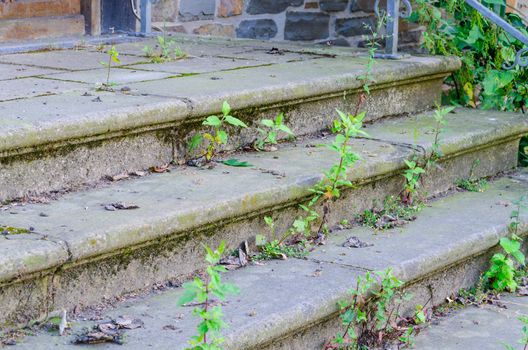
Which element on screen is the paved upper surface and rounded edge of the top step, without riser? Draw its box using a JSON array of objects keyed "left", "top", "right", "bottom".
[{"left": 0, "top": 43, "right": 459, "bottom": 156}]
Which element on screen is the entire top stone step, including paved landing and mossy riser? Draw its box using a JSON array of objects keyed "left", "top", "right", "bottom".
[{"left": 0, "top": 37, "right": 459, "bottom": 202}]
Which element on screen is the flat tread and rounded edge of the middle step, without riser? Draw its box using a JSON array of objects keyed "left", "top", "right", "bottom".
[{"left": 0, "top": 109, "right": 528, "bottom": 281}]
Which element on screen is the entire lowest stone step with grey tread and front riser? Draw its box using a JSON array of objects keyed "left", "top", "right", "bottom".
[{"left": 8, "top": 171, "right": 528, "bottom": 350}]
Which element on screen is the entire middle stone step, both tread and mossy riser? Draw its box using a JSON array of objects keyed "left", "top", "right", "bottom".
[{"left": 0, "top": 109, "right": 528, "bottom": 323}]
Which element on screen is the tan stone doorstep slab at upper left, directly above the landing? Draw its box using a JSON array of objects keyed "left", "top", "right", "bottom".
[{"left": 0, "top": 15, "right": 84, "bottom": 42}]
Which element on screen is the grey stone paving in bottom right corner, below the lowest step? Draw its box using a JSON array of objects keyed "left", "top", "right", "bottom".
[{"left": 414, "top": 295, "right": 528, "bottom": 350}]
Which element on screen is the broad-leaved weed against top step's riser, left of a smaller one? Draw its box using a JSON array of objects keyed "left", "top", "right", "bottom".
[{"left": 189, "top": 101, "right": 247, "bottom": 162}]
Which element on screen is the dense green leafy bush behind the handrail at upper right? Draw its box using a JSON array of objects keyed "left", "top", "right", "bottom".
[{"left": 411, "top": 0, "right": 528, "bottom": 112}]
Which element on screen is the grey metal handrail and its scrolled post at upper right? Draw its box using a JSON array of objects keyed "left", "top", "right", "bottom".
[{"left": 374, "top": 0, "right": 528, "bottom": 69}]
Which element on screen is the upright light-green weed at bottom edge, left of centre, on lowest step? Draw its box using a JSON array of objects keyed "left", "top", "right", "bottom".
[{"left": 179, "top": 242, "right": 239, "bottom": 350}]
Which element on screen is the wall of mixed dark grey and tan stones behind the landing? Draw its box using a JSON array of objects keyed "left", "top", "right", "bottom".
[{"left": 153, "top": 0, "right": 406, "bottom": 46}]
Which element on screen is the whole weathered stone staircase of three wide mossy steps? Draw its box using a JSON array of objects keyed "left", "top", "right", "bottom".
[{"left": 0, "top": 37, "right": 528, "bottom": 349}]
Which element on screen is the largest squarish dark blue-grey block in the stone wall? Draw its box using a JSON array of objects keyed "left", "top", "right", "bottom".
[{"left": 284, "top": 12, "right": 330, "bottom": 40}]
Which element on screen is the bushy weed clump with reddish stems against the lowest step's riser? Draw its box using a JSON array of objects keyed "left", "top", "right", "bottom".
[{"left": 324, "top": 269, "right": 425, "bottom": 350}]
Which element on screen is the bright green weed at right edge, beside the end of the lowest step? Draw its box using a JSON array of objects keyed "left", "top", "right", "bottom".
[{"left": 483, "top": 196, "right": 527, "bottom": 292}]
